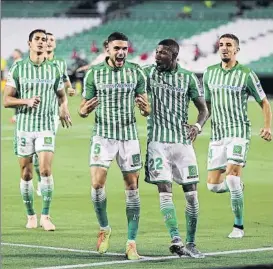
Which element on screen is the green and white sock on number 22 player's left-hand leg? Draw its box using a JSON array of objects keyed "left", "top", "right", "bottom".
[{"left": 159, "top": 192, "right": 180, "bottom": 238}]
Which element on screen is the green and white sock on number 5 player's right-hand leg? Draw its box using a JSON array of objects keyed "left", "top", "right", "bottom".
[{"left": 125, "top": 190, "right": 140, "bottom": 240}]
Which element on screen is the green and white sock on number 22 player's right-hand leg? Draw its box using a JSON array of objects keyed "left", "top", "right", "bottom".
[{"left": 185, "top": 191, "right": 199, "bottom": 243}]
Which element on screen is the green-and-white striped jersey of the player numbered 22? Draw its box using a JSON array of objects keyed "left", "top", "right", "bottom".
[{"left": 143, "top": 64, "right": 203, "bottom": 144}]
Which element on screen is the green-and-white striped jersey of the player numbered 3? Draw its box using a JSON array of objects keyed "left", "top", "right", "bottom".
[{"left": 7, "top": 58, "right": 63, "bottom": 132}]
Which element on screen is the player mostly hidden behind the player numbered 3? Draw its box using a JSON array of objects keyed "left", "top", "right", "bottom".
[{"left": 33, "top": 33, "right": 76, "bottom": 196}]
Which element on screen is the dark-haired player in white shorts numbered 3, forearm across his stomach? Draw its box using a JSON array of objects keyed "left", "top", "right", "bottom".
[{"left": 3, "top": 29, "right": 71, "bottom": 231}]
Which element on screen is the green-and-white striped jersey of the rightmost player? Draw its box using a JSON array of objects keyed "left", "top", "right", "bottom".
[{"left": 203, "top": 63, "right": 266, "bottom": 141}]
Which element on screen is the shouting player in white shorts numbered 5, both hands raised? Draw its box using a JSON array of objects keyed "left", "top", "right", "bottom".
[{"left": 79, "top": 32, "right": 150, "bottom": 260}]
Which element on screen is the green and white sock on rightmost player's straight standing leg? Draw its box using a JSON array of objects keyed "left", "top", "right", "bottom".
[{"left": 227, "top": 175, "right": 244, "bottom": 226}]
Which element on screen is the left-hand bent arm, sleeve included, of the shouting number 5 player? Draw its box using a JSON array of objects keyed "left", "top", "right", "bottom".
[{"left": 79, "top": 69, "right": 99, "bottom": 118}]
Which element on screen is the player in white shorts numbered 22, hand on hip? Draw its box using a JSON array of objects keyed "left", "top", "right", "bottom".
[{"left": 143, "top": 39, "right": 208, "bottom": 258}]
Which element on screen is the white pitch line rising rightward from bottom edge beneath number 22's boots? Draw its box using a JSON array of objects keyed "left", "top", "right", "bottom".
[{"left": 30, "top": 247, "right": 273, "bottom": 269}]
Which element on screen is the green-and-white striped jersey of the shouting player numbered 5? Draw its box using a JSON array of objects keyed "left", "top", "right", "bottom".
[{"left": 82, "top": 58, "right": 147, "bottom": 140}]
